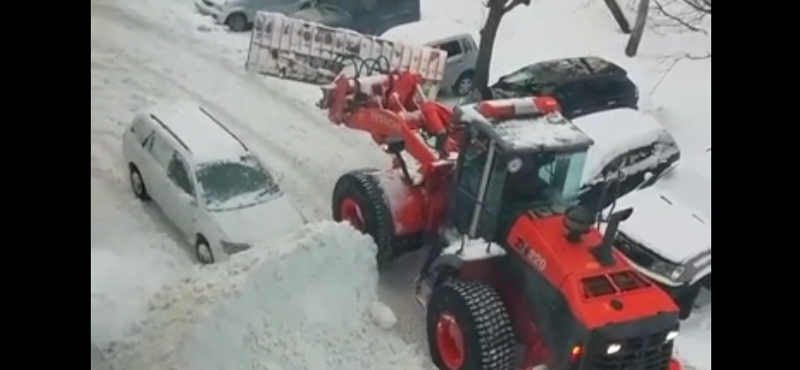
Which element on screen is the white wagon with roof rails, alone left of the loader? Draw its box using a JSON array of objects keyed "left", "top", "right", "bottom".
[{"left": 122, "top": 102, "right": 305, "bottom": 264}]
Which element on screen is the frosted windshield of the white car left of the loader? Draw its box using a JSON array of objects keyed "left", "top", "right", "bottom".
[{"left": 197, "top": 156, "right": 280, "bottom": 211}]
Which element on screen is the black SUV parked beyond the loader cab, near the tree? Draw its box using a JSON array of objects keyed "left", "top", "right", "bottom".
[{"left": 488, "top": 56, "right": 639, "bottom": 118}]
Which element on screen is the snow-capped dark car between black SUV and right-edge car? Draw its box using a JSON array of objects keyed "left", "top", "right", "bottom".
[{"left": 572, "top": 108, "right": 681, "bottom": 208}]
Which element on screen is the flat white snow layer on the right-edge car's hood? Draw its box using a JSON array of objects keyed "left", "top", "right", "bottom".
[{"left": 616, "top": 188, "right": 711, "bottom": 262}]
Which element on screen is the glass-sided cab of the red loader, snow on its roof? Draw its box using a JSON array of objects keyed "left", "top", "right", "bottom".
[{"left": 450, "top": 98, "right": 593, "bottom": 242}]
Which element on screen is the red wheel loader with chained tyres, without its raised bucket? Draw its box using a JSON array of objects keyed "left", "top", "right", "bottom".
[{"left": 251, "top": 16, "right": 683, "bottom": 370}]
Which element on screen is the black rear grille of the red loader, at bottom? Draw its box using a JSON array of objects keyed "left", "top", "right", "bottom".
[{"left": 585, "top": 331, "right": 674, "bottom": 370}]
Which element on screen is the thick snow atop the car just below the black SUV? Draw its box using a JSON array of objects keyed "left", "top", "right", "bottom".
[{"left": 572, "top": 108, "right": 672, "bottom": 183}]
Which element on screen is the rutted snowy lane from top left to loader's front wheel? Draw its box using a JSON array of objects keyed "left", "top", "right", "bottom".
[{"left": 92, "top": 2, "right": 385, "bottom": 219}]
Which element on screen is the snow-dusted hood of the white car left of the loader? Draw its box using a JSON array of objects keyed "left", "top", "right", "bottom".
[{"left": 210, "top": 195, "right": 305, "bottom": 245}]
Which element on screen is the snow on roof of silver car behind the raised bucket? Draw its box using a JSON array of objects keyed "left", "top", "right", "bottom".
[{"left": 381, "top": 18, "right": 477, "bottom": 44}]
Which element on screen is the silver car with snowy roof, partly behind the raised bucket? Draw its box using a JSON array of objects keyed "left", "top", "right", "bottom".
[{"left": 381, "top": 19, "right": 478, "bottom": 96}]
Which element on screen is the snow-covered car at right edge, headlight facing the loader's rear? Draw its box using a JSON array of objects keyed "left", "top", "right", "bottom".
[{"left": 615, "top": 151, "right": 711, "bottom": 319}]
